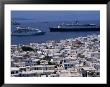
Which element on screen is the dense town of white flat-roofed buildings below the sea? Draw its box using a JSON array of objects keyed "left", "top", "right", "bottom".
[{"left": 11, "top": 35, "right": 100, "bottom": 77}]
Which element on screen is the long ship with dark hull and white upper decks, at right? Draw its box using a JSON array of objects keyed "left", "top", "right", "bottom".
[{"left": 49, "top": 21, "right": 100, "bottom": 32}]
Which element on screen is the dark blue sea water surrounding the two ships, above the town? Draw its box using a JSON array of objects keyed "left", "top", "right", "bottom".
[{"left": 11, "top": 20, "right": 100, "bottom": 44}]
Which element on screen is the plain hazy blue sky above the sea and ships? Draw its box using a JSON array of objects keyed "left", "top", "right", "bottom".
[{"left": 11, "top": 11, "right": 100, "bottom": 21}]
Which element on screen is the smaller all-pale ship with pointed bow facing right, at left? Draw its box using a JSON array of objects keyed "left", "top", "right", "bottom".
[{"left": 11, "top": 27, "right": 45, "bottom": 36}]
